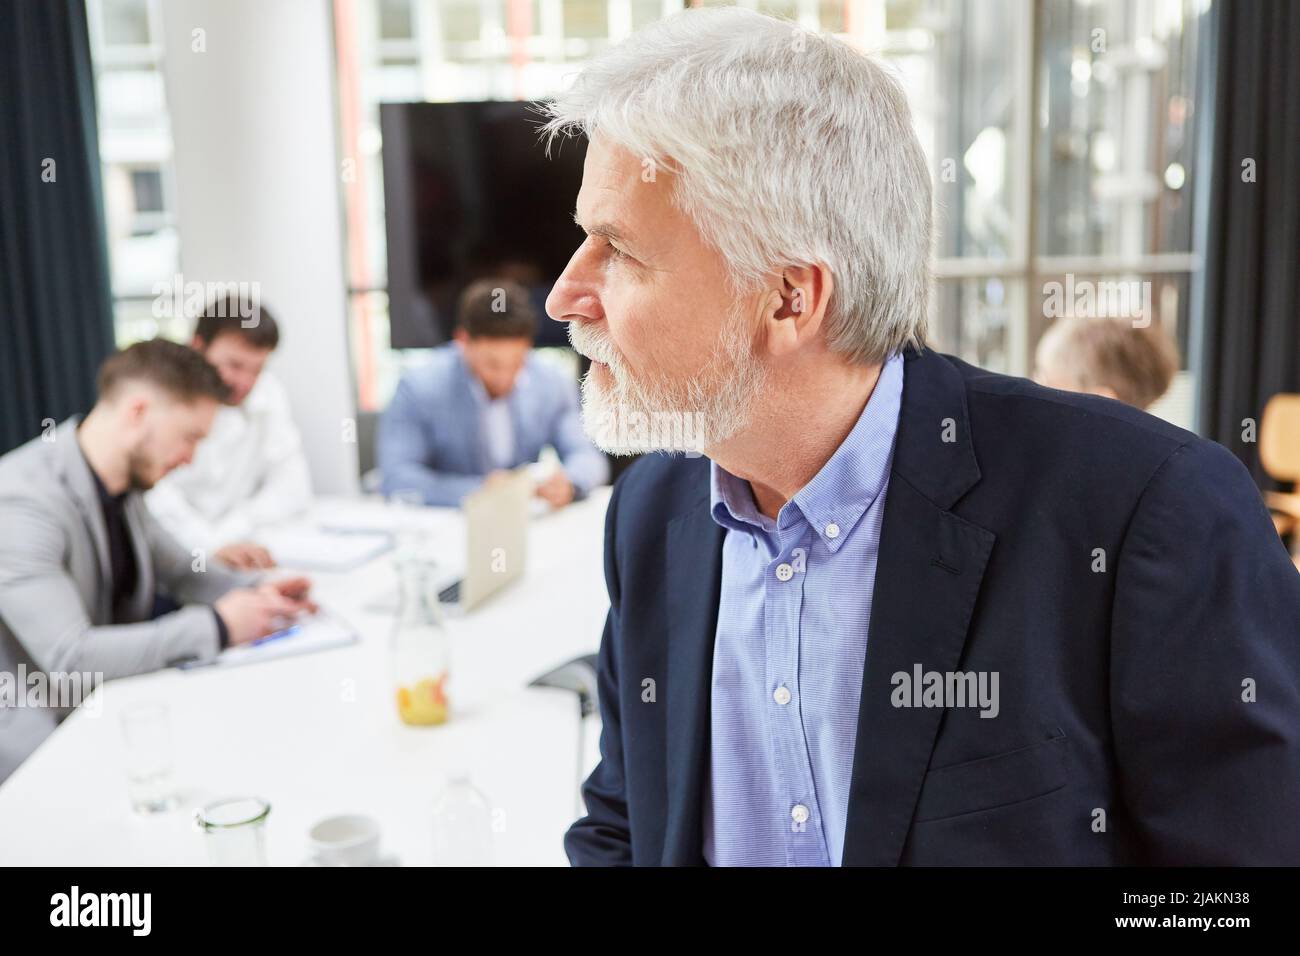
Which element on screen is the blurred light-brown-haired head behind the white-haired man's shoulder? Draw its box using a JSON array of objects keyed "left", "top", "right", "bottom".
[{"left": 1034, "top": 316, "right": 1178, "bottom": 410}]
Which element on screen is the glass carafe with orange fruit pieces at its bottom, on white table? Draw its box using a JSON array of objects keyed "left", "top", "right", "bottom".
[{"left": 393, "top": 555, "right": 451, "bottom": 727}]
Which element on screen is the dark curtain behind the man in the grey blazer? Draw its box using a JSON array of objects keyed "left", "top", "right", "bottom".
[{"left": 0, "top": 0, "right": 113, "bottom": 451}]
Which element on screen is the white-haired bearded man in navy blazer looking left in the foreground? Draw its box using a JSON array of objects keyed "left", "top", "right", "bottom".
[{"left": 542, "top": 7, "right": 1300, "bottom": 866}]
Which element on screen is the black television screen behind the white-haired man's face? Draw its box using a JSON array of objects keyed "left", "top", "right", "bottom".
[{"left": 380, "top": 101, "right": 586, "bottom": 349}]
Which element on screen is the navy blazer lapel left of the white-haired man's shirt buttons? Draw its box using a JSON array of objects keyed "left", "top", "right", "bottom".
[{"left": 659, "top": 494, "right": 725, "bottom": 866}]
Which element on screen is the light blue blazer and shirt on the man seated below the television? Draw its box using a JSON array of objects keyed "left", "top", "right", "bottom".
[{"left": 376, "top": 342, "right": 610, "bottom": 506}]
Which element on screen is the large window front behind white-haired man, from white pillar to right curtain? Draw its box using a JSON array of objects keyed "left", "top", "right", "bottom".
[{"left": 335, "top": 0, "right": 1209, "bottom": 425}]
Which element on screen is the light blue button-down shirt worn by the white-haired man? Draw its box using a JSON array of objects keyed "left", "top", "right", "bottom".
[{"left": 703, "top": 355, "right": 904, "bottom": 866}]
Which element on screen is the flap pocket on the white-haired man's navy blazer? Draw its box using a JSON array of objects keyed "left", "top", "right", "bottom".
[{"left": 913, "top": 734, "right": 1067, "bottom": 823}]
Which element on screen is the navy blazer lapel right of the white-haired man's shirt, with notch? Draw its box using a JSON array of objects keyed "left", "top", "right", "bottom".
[{"left": 842, "top": 352, "right": 996, "bottom": 866}]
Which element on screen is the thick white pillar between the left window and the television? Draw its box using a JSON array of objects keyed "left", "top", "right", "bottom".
[{"left": 161, "top": 0, "right": 359, "bottom": 494}]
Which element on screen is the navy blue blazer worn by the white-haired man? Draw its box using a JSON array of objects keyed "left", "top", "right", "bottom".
[{"left": 564, "top": 350, "right": 1300, "bottom": 866}]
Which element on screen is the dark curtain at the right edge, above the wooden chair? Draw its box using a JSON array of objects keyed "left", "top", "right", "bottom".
[{"left": 1200, "top": 0, "right": 1300, "bottom": 486}]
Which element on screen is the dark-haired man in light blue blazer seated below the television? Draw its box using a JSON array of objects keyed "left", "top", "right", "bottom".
[{"left": 377, "top": 280, "right": 610, "bottom": 507}]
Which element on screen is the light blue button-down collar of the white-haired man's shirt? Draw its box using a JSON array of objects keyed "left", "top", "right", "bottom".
[{"left": 710, "top": 355, "right": 904, "bottom": 554}]
